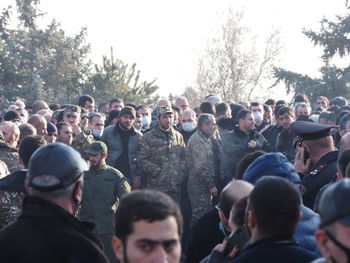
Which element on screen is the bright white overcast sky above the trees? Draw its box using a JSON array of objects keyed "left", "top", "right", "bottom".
[{"left": 0, "top": 0, "right": 345, "bottom": 98}]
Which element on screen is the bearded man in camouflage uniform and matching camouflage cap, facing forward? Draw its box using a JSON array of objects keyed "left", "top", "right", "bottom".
[{"left": 136, "top": 106, "right": 187, "bottom": 204}]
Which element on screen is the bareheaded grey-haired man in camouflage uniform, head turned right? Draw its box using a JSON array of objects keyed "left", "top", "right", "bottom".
[{"left": 187, "top": 114, "right": 218, "bottom": 225}]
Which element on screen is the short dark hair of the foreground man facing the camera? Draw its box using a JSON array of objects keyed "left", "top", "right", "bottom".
[{"left": 115, "top": 190, "right": 182, "bottom": 241}]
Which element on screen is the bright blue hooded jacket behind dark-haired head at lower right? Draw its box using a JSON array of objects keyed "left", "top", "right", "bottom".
[{"left": 243, "top": 152, "right": 320, "bottom": 254}]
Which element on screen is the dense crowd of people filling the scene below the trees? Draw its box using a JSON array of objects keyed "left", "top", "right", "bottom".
[{"left": 0, "top": 94, "right": 350, "bottom": 263}]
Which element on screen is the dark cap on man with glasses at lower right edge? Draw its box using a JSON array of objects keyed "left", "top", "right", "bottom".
[{"left": 319, "top": 178, "right": 350, "bottom": 227}]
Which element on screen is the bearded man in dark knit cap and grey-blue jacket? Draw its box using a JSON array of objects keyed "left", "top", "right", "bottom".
[{"left": 101, "top": 106, "right": 142, "bottom": 187}]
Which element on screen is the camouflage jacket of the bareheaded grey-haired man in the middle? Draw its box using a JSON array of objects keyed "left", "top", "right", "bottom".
[{"left": 187, "top": 130, "right": 216, "bottom": 190}]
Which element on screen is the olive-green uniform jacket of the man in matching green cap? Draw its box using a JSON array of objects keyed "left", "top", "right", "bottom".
[{"left": 79, "top": 165, "right": 131, "bottom": 234}]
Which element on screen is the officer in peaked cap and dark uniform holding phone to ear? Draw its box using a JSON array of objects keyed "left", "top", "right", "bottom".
[{"left": 291, "top": 121, "right": 338, "bottom": 209}]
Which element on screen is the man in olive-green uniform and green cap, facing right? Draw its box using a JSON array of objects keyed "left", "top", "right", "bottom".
[{"left": 79, "top": 141, "right": 131, "bottom": 262}]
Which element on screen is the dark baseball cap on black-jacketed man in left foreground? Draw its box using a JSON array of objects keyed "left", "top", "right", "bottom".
[{"left": 27, "top": 142, "right": 88, "bottom": 192}]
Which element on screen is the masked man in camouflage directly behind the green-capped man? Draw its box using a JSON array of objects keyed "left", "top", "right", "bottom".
[{"left": 72, "top": 112, "right": 105, "bottom": 160}]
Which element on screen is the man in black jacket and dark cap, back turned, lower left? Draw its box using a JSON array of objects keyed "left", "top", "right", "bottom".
[{"left": 0, "top": 143, "right": 109, "bottom": 263}]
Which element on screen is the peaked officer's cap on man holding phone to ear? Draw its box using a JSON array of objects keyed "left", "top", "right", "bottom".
[{"left": 290, "top": 121, "right": 335, "bottom": 141}]
